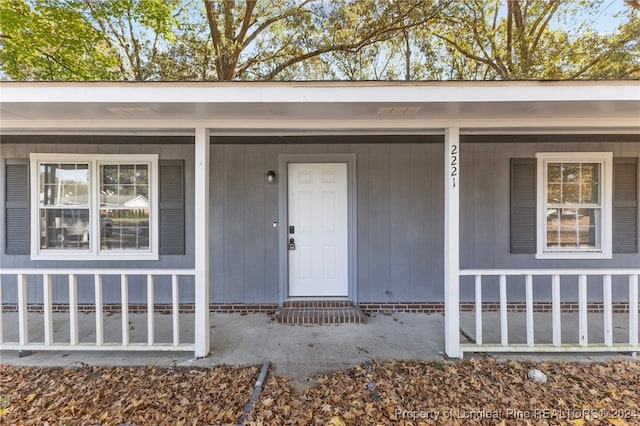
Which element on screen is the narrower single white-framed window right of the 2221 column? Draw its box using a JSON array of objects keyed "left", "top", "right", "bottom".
[{"left": 536, "top": 152, "right": 613, "bottom": 259}]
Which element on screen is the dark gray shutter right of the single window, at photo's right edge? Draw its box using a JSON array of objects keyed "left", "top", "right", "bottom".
[{"left": 613, "top": 157, "right": 638, "bottom": 253}]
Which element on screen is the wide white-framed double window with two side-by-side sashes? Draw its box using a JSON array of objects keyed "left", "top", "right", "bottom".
[{"left": 31, "top": 154, "right": 159, "bottom": 259}]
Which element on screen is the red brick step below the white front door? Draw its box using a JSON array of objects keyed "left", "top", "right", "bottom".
[{"left": 276, "top": 300, "right": 365, "bottom": 325}]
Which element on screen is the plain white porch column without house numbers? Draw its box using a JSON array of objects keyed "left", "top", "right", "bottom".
[{"left": 194, "top": 127, "right": 209, "bottom": 358}]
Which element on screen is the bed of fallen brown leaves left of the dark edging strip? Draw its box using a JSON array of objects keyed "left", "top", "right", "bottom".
[{"left": 0, "top": 365, "right": 259, "bottom": 425}]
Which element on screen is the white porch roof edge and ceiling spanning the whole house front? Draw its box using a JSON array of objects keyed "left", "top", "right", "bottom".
[{"left": 0, "top": 81, "right": 640, "bottom": 135}]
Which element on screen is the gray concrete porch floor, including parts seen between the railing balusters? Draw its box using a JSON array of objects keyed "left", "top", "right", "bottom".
[{"left": 0, "top": 312, "right": 629, "bottom": 387}]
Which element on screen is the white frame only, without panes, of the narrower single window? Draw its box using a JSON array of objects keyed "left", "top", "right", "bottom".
[{"left": 535, "top": 152, "right": 613, "bottom": 259}]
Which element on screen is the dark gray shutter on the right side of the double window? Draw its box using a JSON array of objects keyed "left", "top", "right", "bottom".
[{"left": 158, "top": 160, "right": 185, "bottom": 254}]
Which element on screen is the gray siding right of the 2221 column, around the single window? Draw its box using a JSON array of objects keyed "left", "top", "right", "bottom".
[{"left": 460, "top": 140, "right": 640, "bottom": 301}]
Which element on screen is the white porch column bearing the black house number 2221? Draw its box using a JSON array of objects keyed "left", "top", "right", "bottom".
[{"left": 444, "top": 127, "right": 462, "bottom": 358}]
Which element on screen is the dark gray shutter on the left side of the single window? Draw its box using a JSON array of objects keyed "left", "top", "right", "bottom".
[{"left": 511, "top": 158, "right": 536, "bottom": 254}]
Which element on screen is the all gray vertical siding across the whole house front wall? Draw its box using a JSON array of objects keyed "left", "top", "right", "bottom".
[{"left": 0, "top": 136, "right": 640, "bottom": 303}]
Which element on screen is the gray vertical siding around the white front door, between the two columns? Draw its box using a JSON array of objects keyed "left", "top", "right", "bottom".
[{"left": 211, "top": 142, "right": 444, "bottom": 303}]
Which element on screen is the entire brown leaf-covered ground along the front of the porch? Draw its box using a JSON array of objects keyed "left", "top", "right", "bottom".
[{"left": 0, "top": 358, "right": 640, "bottom": 426}]
